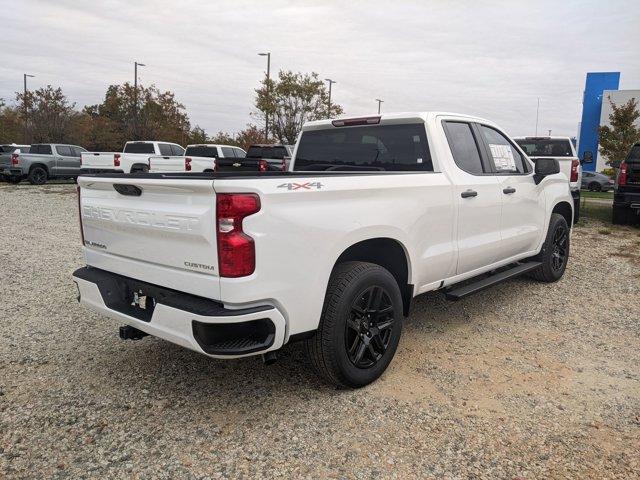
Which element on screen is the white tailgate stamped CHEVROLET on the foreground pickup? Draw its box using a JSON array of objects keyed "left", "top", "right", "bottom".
[{"left": 78, "top": 177, "right": 219, "bottom": 299}]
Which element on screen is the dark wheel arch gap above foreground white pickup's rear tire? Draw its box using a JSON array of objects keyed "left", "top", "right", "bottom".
[{"left": 332, "top": 237, "right": 414, "bottom": 316}]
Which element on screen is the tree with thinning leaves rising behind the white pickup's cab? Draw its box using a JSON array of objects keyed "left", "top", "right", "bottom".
[{"left": 255, "top": 70, "right": 343, "bottom": 144}]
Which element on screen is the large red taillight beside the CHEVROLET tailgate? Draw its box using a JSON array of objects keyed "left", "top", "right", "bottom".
[{"left": 216, "top": 193, "right": 260, "bottom": 277}]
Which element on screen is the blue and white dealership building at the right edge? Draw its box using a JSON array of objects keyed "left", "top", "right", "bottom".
[{"left": 578, "top": 72, "right": 640, "bottom": 172}]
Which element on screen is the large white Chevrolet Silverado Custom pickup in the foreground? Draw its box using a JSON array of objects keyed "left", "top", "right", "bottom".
[{"left": 73, "top": 113, "right": 573, "bottom": 387}]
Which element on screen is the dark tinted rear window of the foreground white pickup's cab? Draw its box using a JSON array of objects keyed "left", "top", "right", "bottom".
[{"left": 294, "top": 124, "right": 433, "bottom": 171}]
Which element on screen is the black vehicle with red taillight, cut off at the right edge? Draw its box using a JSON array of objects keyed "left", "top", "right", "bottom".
[{"left": 613, "top": 142, "right": 640, "bottom": 225}]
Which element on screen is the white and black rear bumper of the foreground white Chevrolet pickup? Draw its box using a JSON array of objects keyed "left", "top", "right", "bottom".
[{"left": 73, "top": 267, "right": 286, "bottom": 358}]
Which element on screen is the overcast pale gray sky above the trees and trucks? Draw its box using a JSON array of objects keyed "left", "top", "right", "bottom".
[{"left": 0, "top": 0, "right": 640, "bottom": 136}]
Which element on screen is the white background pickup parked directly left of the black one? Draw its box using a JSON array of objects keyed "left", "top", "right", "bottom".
[{"left": 149, "top": 143, "right": 247, "bottom": 173}]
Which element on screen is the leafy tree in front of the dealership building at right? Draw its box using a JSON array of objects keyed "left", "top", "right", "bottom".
[{"left": 598, "top": 97, "right": 640, "bottom": 165}]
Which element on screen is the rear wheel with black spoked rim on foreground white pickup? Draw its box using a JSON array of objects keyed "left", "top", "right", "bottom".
[{"left": 305, "top": 262, "right": 402, "bottom": 388}]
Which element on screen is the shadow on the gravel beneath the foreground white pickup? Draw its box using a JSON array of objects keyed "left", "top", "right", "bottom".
[{"left": 87, "top": 278, "right": 540, "bottom": 408}]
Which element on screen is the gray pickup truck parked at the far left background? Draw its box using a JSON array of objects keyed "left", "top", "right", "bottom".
[{"left": 0, "top": 143, "right": 86, "bottom": 185}]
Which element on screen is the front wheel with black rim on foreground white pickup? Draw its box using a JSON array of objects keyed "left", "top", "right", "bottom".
[{"left": 530, "top": 213, "right": 571, "bottom": 283}]
